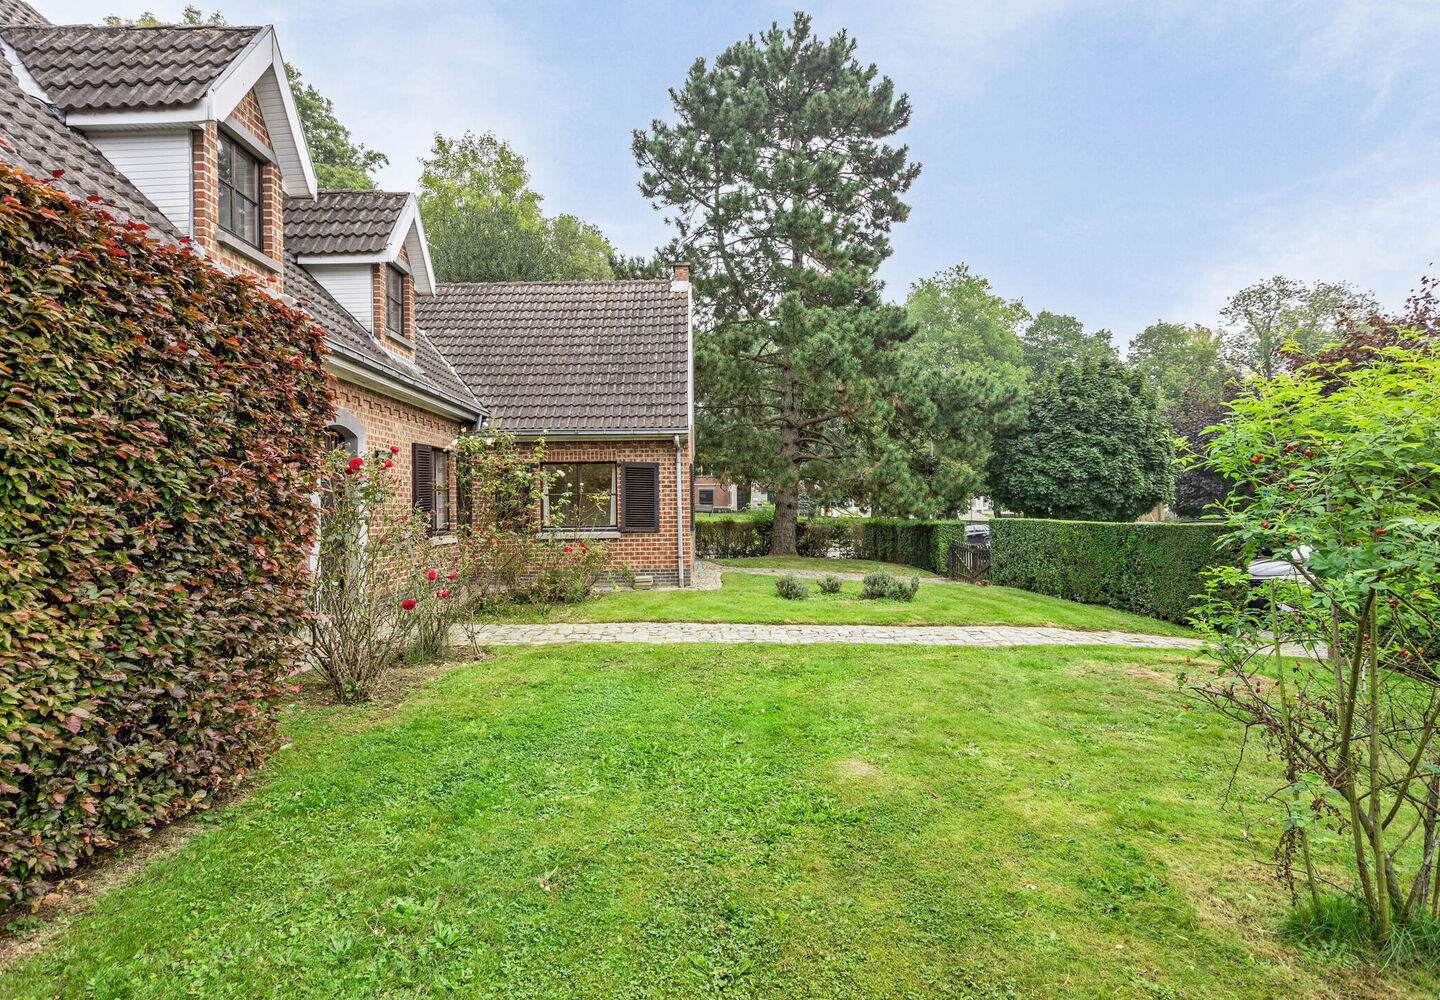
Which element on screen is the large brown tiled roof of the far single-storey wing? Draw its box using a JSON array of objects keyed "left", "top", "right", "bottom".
[{"left": 416, "top": 280, "right": 690, "bottom": 432}]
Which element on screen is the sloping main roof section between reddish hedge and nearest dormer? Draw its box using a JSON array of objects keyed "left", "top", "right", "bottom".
[{"left": 0, "top": 51, "right": 180, "bottom": 239}]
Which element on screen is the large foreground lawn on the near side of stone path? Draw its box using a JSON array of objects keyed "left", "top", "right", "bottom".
[{"left": 4, "top": 646, "right": 1437, "bottom": 1000}]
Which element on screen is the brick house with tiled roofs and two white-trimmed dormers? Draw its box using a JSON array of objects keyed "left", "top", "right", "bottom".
[{"left": 0, "top": 7, "right": 693, "bottom": 584}]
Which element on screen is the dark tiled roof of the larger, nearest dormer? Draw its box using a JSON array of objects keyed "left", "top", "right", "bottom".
[{"left": 0, "top": 24, "right": 264, "bottom": 111}]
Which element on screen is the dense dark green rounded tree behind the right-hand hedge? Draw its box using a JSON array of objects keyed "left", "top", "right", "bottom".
[{"left": 988, "top": 359, "right": 1175, "bottom": 520}]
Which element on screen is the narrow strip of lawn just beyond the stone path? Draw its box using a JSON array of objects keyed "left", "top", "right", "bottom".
[{"left": 535, "top": 573, "right": 1187, "bottom": 635}]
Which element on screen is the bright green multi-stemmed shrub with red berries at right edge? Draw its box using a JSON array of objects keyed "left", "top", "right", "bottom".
[{"left": 1182, "top": 344, "right": 1440, "bottom": 947}]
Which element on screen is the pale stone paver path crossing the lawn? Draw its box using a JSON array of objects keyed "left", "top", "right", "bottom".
[{"left": 451, "top": 621, "right": 1200, "bottom": 650}]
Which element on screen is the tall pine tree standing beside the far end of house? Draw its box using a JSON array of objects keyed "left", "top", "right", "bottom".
[{"left": 632, "top": 13, "right": 920, "bottom": 553}]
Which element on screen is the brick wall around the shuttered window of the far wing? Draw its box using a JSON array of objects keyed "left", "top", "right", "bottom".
[{"left": 546, "top": 439, "right": 696, "bottom": 582}]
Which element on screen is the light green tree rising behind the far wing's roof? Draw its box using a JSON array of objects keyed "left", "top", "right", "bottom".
[{"left": 419, "top": 133, "right": 615, "bottom": 281}]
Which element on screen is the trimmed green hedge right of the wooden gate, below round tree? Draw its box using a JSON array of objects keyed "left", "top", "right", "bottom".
[{"left": 991, "top": 517, "right": 1231, "bottom": 621}]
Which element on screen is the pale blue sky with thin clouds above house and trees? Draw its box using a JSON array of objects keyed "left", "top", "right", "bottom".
[{"left": 45, "top": 0, "right": 1440, "bottom": 350}]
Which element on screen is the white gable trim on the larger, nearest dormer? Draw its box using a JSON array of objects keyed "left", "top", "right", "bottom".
[{"left": 66, "top": 26, "right": 318, "bottom": 197}]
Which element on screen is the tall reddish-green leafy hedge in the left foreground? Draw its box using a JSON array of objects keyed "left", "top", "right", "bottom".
[{"left": 0, "top": 164, "right": 331, "bottom": 903}]
